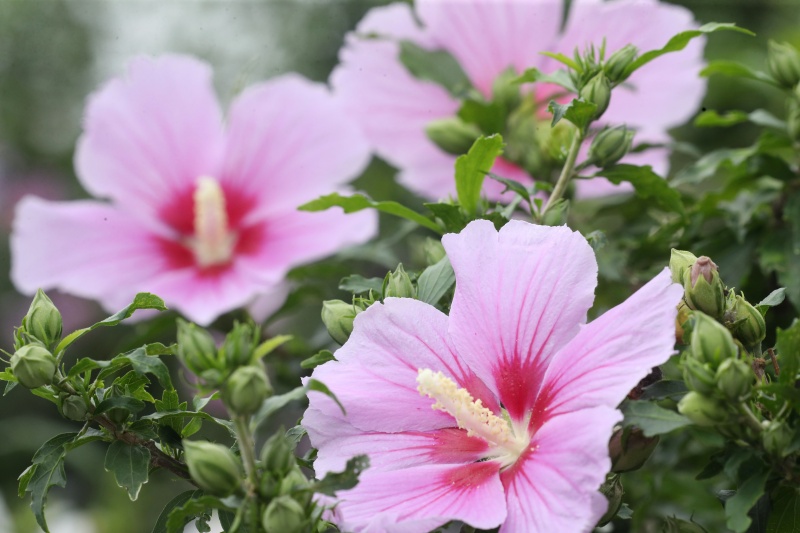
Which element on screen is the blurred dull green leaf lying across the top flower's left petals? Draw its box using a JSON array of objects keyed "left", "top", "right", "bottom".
[{"left": 400, "top": 41, "right": 472, "bottom": 97}]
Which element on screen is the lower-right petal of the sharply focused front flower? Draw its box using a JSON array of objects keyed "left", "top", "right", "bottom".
[{"left": 500, "top": 407, "right": 622, "bottom": 533}]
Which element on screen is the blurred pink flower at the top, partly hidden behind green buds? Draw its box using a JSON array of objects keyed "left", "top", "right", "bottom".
[{"left": 331, "top": 0, "right": 705, "bottom": 199}]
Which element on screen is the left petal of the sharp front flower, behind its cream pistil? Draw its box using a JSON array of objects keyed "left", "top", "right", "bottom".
[{"left": 309, "top": 298, "right": 498, "bottom": 432}]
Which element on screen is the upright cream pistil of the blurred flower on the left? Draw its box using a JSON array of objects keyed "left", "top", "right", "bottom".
[{"left": 189, "top": 176, "right": 236, "bottom": 268}]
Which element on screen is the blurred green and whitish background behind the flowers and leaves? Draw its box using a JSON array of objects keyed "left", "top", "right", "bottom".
[{"left": 0, "top": 0, "right": 800, "bottom": 533}]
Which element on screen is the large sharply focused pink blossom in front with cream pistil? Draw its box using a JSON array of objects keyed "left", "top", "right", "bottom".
[{"left": 303, "top": 221, "right": 682, "bottom": 532}]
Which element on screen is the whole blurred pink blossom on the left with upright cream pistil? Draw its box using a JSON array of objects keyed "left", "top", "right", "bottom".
[{"left": 11, "top": 56, "right": 377, "bottom": 324}]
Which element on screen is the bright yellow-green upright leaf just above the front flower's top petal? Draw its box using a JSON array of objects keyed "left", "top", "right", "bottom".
[{"left": 456, "top": 135, "right": 503, "bottom": 216}]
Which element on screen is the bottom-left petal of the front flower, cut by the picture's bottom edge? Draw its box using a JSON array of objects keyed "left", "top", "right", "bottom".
[{"left": 337, "top": 461, "right": 506, "bottom": 532}]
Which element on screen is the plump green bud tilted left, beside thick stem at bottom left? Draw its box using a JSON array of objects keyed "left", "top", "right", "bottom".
[{"left": 183, "top": 440, "right": 242, "bottom": 497}]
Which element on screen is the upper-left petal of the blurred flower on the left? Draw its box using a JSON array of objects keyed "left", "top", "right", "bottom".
[{"left": 75, "top": 55, "right": 224, "bottom": 221}]
